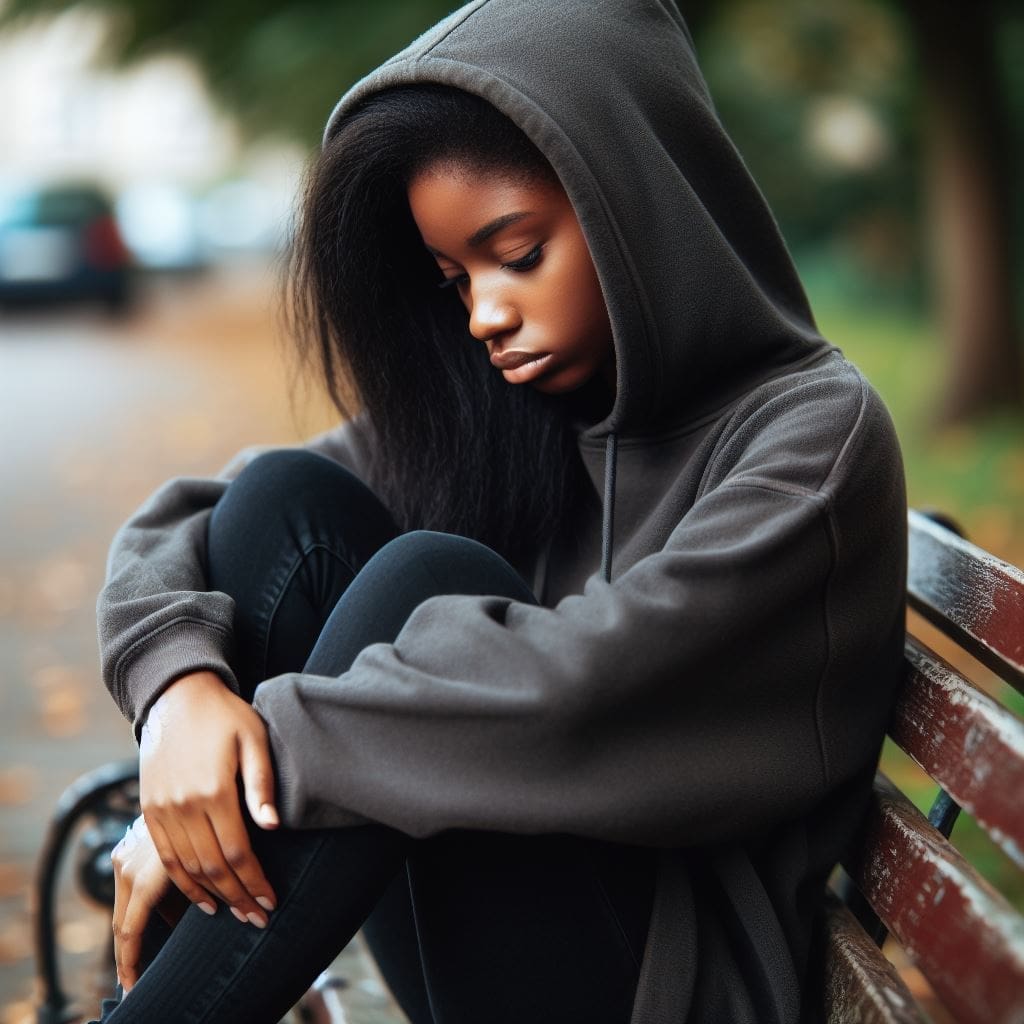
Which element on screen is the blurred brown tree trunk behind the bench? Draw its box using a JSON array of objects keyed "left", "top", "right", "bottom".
[{"left": 906, "top": 0, "right": 1024, "bottom": 423}]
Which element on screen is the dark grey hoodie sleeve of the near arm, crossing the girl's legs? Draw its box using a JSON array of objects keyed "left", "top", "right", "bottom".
[{"left": 255, "top": 387, "right": 904, "bottom": 846}]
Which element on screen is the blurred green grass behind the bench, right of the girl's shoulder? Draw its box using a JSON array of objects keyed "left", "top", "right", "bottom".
[{"left": 812, "top": 294, "right": 1024, "bottom": 911}]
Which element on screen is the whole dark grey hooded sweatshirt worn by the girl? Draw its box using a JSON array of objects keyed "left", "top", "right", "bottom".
[{"left": 99, "top": 0, "right": 905, "bottom": 1024}]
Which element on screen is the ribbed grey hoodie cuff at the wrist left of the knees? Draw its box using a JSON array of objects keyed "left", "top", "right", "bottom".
[{"left": 116, "top": 622, "right": 240, "bottom": 740}]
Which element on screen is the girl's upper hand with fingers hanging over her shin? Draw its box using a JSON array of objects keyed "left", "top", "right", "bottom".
[{"left": 139, "top": 672, "right": 279, "bottom": 928}]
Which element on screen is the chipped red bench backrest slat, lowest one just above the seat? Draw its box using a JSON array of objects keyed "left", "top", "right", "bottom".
[{"left": 844, "top": 773, "right": 1024, "bottom": 1024}]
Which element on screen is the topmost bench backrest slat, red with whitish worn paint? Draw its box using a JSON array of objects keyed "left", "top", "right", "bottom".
[{"left": 907, "top": 510, "right": 1024, "bottom": 692}]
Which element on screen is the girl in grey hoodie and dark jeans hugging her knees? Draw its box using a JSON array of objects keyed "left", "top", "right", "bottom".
[{"left": 99, "top": 0, "right": 905, "bottom": 1024}]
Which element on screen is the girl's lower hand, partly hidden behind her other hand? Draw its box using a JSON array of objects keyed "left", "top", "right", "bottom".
[{"left": 111, "top": 815, "right": 192, "bottom": 992}]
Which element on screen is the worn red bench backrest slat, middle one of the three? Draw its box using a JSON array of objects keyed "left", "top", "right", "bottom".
[{"left": 889, "top": 637, "right": 1024, "bottom": 867}]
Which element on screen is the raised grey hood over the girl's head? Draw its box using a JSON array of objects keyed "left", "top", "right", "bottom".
[{"left": 325, "top": 0, "right": 831, "bottom": 436}]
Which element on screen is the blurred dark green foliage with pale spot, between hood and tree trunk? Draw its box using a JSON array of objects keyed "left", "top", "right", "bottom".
[{"left": 699, "top": 0, "right": 922, "bottom": 299}]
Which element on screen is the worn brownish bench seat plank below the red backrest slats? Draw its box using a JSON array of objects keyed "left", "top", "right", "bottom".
[{"left": 822, "top": 894, "right": 927, "bottom": 1024}]
